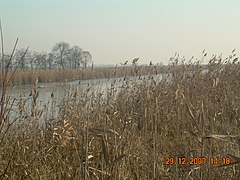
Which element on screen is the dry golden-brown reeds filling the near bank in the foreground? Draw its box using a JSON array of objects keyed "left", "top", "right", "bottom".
[{"left": 0, "top": 57, "right": 240, "bottom": 179}]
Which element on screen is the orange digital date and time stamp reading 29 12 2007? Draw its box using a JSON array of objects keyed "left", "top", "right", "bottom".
[{"left": 164, "top": 157, "right": 231, "bottom": 165}]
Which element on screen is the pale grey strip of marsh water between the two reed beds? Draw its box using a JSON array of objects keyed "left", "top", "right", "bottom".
[{"left": 4, "top": 74, "right": 165, "bottom": 117}]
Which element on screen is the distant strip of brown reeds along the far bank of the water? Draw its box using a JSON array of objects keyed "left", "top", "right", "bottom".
[{"left": 0, "top": 66, "right": 160, "bottom": 86}]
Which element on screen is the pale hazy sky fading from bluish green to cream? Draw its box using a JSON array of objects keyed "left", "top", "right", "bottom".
[{"left": 0, "top": 0, "right": 240, "bottom": 64}]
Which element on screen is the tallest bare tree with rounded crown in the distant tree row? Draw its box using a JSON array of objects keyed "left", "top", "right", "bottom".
[{"left": 52, "top": 42, "right": 70, "bottom": 69}]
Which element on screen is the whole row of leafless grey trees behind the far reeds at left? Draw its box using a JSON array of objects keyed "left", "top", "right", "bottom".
[{"left": 0, "top": 42, "right": 92, "bottom": 70}]
